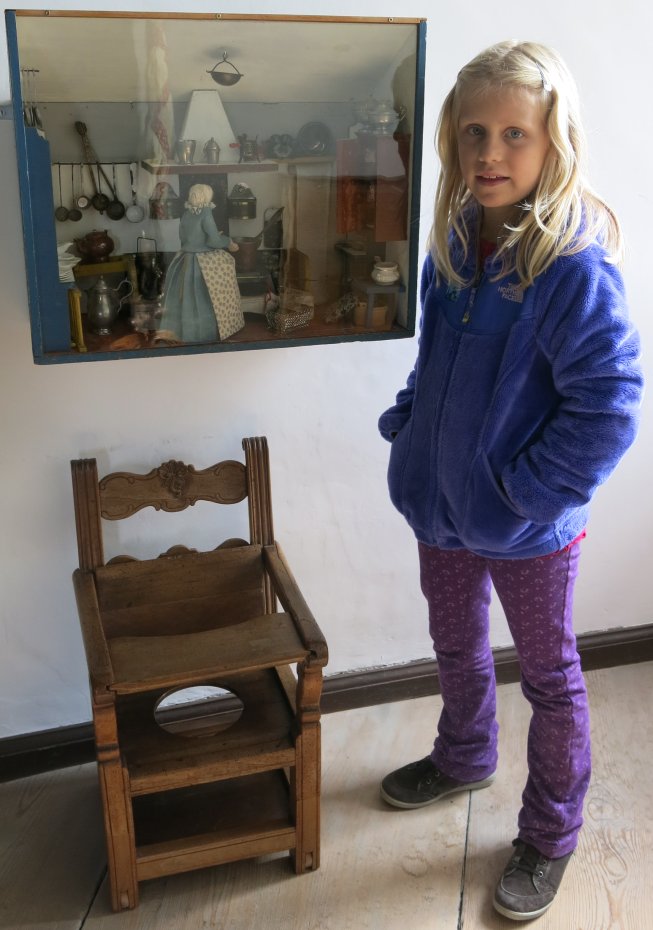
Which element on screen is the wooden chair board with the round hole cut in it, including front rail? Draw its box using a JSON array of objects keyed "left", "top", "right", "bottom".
[{"left": 117, "top": 669, "right": 295, "bottom": 796}]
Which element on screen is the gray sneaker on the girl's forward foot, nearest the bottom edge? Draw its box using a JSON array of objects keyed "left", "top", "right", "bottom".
[{"left": 493, "top": 840, "right": 573, "bottom": 920}]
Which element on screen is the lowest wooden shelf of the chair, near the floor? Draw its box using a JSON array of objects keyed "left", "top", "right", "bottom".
[{"left": 134, "top": 772, "right": 295, "bottom": 881}]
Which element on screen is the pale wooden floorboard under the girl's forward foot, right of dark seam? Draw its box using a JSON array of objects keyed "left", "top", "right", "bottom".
[{"left": 460, "top": 663, "right": 653, "bottom": 930}]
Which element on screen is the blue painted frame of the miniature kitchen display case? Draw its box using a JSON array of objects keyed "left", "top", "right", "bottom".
[{"left": 5, "top": 10, "right": 426, "bottom": 364}]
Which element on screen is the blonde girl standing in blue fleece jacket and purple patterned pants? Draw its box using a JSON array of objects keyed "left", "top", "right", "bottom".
[{"left": 379, "top": 42, "right": 642, "bottom": 920}]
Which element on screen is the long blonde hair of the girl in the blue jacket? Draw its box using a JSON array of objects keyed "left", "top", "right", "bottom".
[{"left": 429, "top": 42, "right": 623, "bottom": 286}]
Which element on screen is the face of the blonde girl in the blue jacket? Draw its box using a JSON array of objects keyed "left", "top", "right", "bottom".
[{"left": 458, "top": 87, "right": 550, "bottom": 240}]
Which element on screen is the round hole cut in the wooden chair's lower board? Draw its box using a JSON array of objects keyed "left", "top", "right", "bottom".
[{"left": 154, "top": 685, "right": 244, "bottom": 737}]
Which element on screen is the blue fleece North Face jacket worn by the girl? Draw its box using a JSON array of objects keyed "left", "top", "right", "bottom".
[{"left": 379, "top": 245, "right": 642, "bottom": 558}]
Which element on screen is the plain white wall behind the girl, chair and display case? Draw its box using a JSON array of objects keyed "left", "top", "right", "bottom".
[{"left": 0, "top": 0, "right": 653, "bottom": 737}]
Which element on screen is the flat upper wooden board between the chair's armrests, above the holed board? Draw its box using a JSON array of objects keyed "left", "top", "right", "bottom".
[{"left": 108, "top": 613, "right": 308, "bottom": 694}]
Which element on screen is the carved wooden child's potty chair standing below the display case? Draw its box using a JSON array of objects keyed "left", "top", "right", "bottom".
[{"left": 71, "top": 437, "right": 327, "bottom": 911}]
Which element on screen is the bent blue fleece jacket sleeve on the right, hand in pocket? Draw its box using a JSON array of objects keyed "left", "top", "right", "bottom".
[{"left": 501, "top": 246, "right": 643, "bottom": 523}]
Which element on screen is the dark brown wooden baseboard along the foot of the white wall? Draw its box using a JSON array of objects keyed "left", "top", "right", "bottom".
[{"left": 0, "top": 624, "right": 653, "bottom": 781}]
